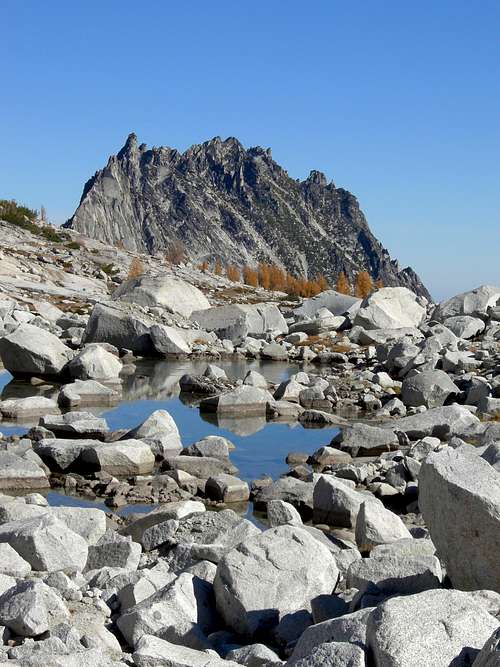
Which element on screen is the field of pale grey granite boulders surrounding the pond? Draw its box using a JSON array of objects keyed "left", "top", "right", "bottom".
[{"left": 0, "top": 252, "right": 500, "bottom": 667}]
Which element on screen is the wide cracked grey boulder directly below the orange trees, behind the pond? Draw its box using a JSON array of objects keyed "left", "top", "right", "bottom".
[{"left": 191, "top": 303, "right": 288, "bottom": 343}]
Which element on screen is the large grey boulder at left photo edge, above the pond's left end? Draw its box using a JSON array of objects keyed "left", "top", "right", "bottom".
[{"left": 0, "top": 324, "right": 73, "bottom": 376}]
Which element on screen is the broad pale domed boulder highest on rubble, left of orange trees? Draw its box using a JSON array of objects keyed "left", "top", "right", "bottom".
[{"left": 113, "top": 274, "right": 210, "bottom": 317}]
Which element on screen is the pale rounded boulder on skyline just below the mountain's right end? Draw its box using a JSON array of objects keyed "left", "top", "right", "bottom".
[{"left": 354, "top": 287, "right": 426, "bottom": 330}]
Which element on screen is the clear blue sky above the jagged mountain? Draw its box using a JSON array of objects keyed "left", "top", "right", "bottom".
[{"left": 0, "top": 0, "right": 500, "bottom": 299}]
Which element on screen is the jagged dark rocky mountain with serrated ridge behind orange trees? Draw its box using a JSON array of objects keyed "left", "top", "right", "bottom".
[{"left": 67, "top": 134, "right": 429, "bottom": 297}]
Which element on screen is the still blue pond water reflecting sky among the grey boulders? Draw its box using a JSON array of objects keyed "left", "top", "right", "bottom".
[{"left": 0, "top": 360, "right": 337, "bottom": 511}]
